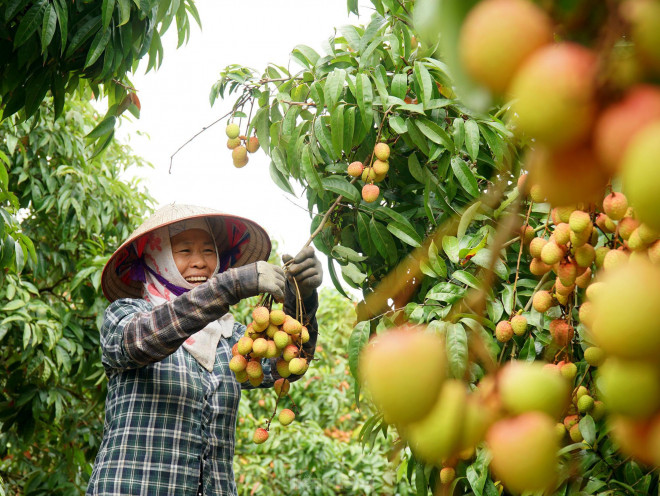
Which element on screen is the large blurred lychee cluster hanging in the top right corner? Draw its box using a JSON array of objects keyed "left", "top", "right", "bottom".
[{"left": 458, "top": 0, "right": 660, "bottom": 225}]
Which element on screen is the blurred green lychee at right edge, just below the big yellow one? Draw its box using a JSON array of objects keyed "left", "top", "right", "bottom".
[{"left": 597, "top": 358, "right": 660, "bottom": 419}]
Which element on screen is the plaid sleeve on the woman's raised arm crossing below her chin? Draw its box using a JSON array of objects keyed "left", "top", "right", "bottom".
[{"left": 101, "top": 264, "right": 258, "bottom": 369}]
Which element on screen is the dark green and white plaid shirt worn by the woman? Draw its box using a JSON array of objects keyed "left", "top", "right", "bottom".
[{"left": 87, "top": 265, "right": 318, "bottom": 496}]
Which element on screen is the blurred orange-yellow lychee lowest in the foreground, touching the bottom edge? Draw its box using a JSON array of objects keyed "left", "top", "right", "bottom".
[{"left": 486, "top": 412, "right": 559, "bottom": 493}]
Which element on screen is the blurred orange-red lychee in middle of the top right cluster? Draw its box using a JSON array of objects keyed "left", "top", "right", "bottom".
[{"left": 510, "top": 42, "right": 596, "bottom": 148}]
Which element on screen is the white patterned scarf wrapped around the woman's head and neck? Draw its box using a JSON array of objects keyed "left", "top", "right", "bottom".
[{"left": 142, "top": 218, "right": 234, "bottom": 372}]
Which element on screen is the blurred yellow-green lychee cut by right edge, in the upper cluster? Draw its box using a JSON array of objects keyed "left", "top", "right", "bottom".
[{"left": 621, "top": 122, "right": 660, "bottom": 230}]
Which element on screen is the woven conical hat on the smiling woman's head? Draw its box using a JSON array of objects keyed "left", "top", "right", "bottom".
[{"left": 101, "top": 204, "right": 271, "bottom": 301}]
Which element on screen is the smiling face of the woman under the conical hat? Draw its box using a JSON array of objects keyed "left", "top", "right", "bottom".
[{"left": 170, "top": 229, "right": 218, "bottom": 286}]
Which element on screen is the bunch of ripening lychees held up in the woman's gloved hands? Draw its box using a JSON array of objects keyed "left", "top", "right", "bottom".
[{"left": 229, "top": 300, "right": 309, "bottom": 444}]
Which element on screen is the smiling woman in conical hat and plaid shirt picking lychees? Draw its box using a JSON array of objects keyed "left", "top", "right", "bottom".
[{"left": 87, "top": 205, "right": 322, "bottom": 496}]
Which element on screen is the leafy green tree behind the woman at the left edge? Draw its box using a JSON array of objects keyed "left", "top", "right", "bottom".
[{"left": 0, "top": 91, "right": 153, "bottom": 494}]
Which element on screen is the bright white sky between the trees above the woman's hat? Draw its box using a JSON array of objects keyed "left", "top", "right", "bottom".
[{"left": 118, "top": 0, "right": 358, "bottom": 289}]
